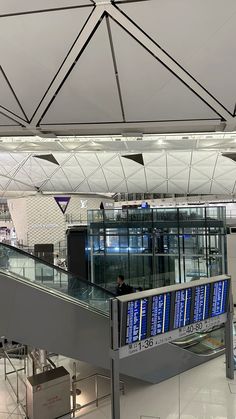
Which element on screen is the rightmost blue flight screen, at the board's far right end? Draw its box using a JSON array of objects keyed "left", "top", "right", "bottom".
[{"left": 211, "top": 279, "right": 229, "bottom": 317}]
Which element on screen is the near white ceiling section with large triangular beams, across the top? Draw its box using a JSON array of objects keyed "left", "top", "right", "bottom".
[{"left": 0, "top": 0, "right": 236, "bottom": 136}]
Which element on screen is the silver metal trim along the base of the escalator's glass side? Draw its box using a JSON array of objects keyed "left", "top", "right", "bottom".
[{"left": 0, "top": 269, "right": 109, "bottom": 317}]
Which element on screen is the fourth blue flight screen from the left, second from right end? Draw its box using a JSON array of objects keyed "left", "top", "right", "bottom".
[{"left": 193, "top": 284, "right": 211, "bottom": 323}]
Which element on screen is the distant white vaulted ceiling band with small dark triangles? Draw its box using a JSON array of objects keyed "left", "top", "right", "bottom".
[{"left": 0, "top": 133, "right": 236, "bottom": 196}]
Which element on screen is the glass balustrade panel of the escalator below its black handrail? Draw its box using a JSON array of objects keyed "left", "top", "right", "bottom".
[{"left": 0, "top": 243, "right": 114, "bottom": 315}]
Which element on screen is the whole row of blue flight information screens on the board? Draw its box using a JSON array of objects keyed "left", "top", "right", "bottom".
[{"left": 120, "top": 279, "right": 230, "bottom": 347}]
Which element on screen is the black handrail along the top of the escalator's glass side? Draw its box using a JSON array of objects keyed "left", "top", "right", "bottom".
[{"left": 0, "top": 242, "right": 116, "bottom": 298}]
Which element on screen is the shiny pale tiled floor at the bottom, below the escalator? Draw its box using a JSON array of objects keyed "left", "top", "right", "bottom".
[{"left": 0, "top": 356, "right": 236, "bottom": 419}]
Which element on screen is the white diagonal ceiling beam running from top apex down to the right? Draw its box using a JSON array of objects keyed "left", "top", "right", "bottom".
[{"left": 106, "top": 4, "right": 235, "bottom": 125}]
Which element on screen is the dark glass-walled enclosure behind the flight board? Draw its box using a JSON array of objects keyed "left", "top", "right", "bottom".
[{"left": 88, "top": 207, "right": 226, "bottom": 288}]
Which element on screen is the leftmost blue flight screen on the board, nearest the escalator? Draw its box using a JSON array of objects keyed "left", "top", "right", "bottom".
[{"left": 126, "top": 298, "right": 148, "bottom": 344}]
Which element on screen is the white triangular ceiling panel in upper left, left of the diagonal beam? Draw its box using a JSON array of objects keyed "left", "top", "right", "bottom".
[{"left": 0, "top": 7, "right": 91, "bottom": 117}]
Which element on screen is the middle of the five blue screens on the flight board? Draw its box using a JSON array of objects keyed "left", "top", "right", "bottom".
[{"left": 174, "top": 288, "right": 192, "bottom": 329}]
